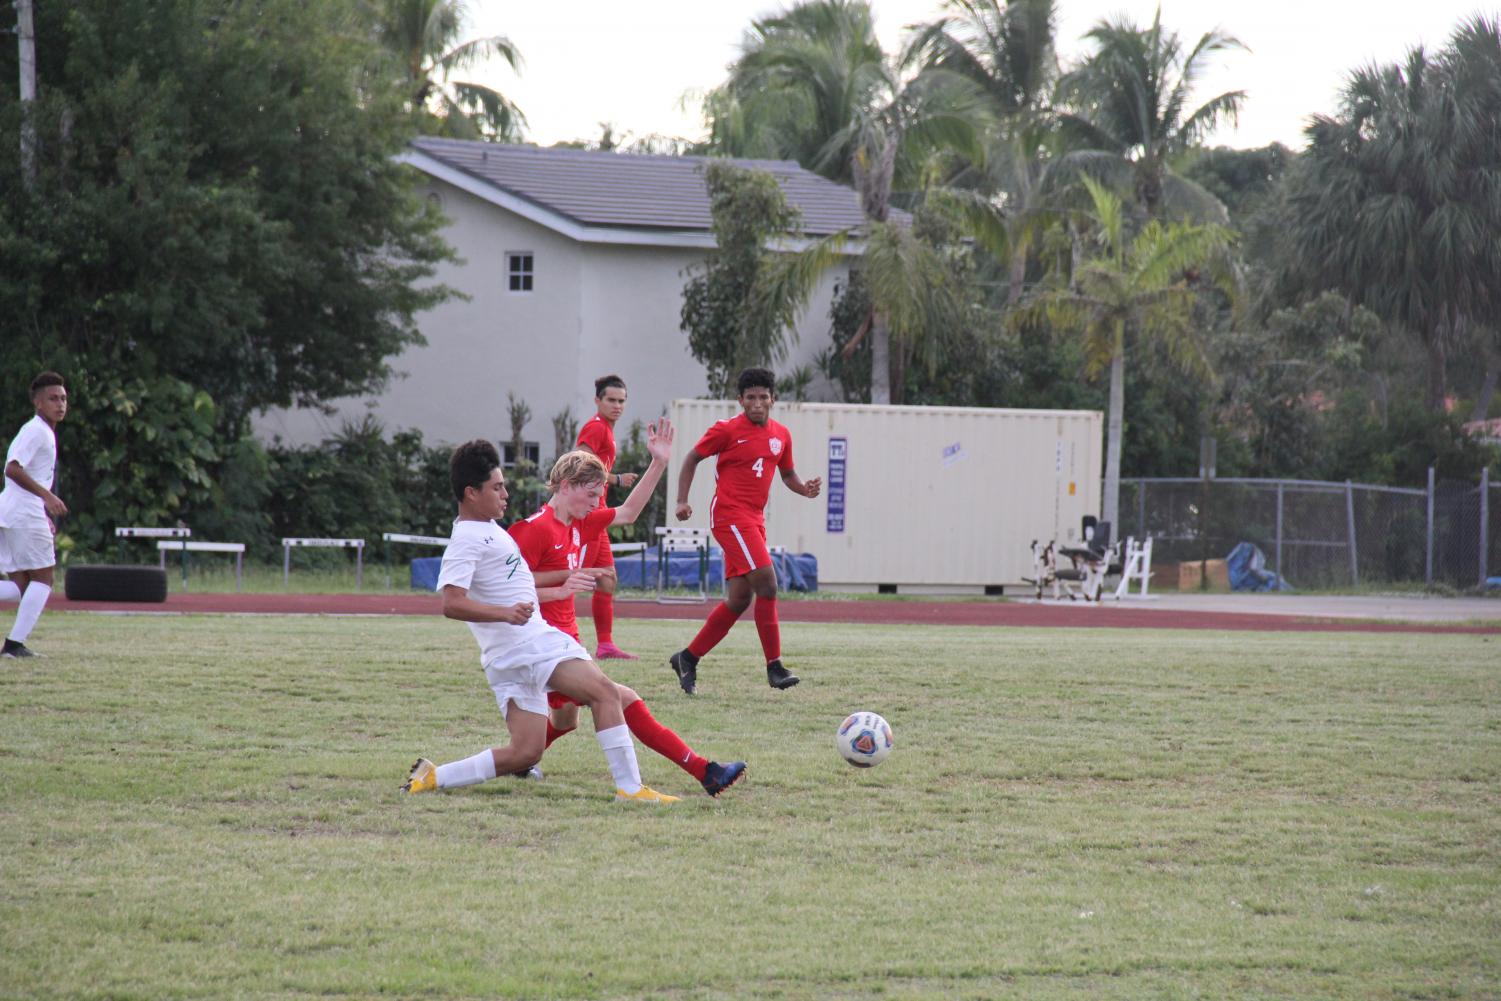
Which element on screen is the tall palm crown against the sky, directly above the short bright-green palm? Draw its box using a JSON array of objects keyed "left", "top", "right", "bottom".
[{"left": 1060, "top": 8, "right": 1246, "bottom": 222}]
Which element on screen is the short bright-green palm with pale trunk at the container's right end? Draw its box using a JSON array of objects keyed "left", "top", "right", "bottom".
[{"left": 1018, "top": 177, "right": 1235, "bottom": 527}]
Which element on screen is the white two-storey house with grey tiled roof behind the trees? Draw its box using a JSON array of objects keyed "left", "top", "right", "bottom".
[{"left": 257, "top": 138, "right": 862, "bottom": 459}]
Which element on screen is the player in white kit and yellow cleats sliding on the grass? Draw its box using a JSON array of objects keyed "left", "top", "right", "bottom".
[{"left": 402, "top": 440, "right": 677, "bottom": 803}]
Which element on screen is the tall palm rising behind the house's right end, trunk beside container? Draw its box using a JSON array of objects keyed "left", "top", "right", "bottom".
[{"left": 705, "top": 0, "right": 986, "bottom": 404}]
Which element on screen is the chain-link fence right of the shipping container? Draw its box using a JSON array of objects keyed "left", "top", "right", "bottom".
[{"left": 1117, "top": 476, "right": 1501, "bottom": 588}]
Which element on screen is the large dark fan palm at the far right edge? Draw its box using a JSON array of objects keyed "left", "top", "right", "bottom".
[{"left": 1279, "top": 17, "right": 1501, "bottom": 410}]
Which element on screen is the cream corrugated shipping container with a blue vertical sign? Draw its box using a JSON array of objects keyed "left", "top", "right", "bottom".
[{"left": 666, "top": 399, "right": 1103, "bottom": 593}]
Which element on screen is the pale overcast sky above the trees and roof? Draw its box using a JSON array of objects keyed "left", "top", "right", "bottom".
[{"left": 461, "top": 0, "right": 1501, "bottom": 149}]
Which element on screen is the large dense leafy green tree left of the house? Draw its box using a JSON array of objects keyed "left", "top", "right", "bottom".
[{"left": 0, "top": 0, "right": 450, "bottom": 549}]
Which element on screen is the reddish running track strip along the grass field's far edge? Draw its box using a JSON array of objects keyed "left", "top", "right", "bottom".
[{"left": 48, "top": 594, "right": 1501, "bottom": 635}]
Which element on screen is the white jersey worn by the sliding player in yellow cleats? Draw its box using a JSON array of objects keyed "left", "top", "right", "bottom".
[{"left": 438, "top": 521, "right": 552, "bottom": 666}]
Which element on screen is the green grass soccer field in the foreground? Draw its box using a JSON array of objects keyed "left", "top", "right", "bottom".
[{"left": 0, "top": 614, "right": 1501, "bottom": 999}]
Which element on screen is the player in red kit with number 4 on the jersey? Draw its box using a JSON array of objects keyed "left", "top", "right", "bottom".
[{"left": 669, "top": 368, "right": 823, "bottom": 695}]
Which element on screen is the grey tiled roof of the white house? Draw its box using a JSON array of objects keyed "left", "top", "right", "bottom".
[{"left": 413, "top": 137, "right": 876, "bottom": 237}]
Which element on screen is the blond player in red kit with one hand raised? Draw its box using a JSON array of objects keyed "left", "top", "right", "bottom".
[{"left": 510, "top": 417, "right": 746, "bottom": 795}]
